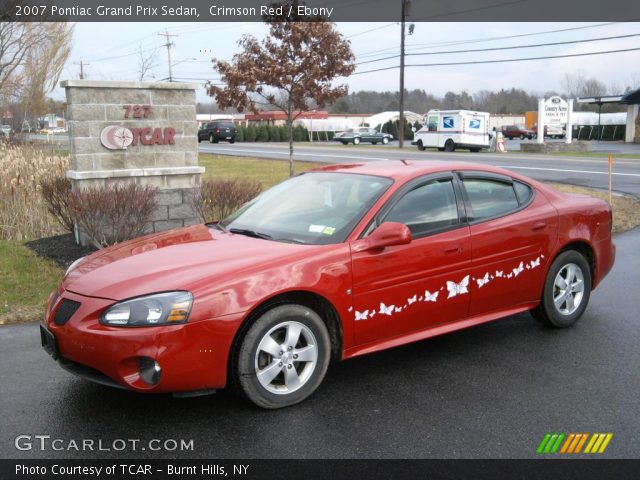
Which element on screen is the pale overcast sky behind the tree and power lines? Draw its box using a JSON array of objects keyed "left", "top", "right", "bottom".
[{"left": 56, "top": 22, "right": 640, "bottom": 102}]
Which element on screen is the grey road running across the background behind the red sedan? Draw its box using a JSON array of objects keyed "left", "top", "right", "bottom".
[{"left": 199, "top": 142, "right": 640, "bottom": 196}]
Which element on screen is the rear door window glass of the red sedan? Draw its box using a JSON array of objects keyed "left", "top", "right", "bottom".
[{"left": 462, "top": 178, "right": 526, "bottom": 220}]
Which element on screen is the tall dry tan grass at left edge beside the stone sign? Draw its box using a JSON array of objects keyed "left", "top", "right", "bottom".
[{"left": 0, "top": 142, "right": 69, "bottom": 240}]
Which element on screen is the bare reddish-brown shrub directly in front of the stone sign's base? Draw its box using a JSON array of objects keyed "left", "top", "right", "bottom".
[{"left": 69, "top": 183, "right": 158, "bottom": 248}]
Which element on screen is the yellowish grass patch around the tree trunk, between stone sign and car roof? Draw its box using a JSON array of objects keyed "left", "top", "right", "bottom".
[{"left": 200, "top": 153, "right": 323, "bottom": 189}]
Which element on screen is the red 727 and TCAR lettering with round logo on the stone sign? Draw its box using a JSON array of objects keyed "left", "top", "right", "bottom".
[{"left": 100, "top": 105, "right": 176, "bottom": 150}]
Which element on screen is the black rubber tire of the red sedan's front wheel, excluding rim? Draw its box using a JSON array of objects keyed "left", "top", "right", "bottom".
[{"left": 235, "top": 304, "right": 331, "bottom": 409}]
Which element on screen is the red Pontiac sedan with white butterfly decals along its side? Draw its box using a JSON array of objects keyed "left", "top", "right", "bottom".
[{"left": 41, "top": 161, "right": 615, "bottom": 408}]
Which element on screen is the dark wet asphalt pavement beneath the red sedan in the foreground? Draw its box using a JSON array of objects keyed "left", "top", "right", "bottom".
[{"left": 0, "top": 229, "right": 640, "bottom": 459}]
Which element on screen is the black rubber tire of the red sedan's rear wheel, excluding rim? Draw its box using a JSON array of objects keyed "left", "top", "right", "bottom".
[{"left": 542, "top": 250, "right": 591, "bottom": 328}]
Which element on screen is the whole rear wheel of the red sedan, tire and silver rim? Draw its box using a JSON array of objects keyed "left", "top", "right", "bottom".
[{"left": 532, "top": 250, "right": 591, "bottom": 328}]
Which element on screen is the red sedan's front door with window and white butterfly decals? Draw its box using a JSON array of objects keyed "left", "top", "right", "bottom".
[{"left": 352, "top": 174, "right": 471, "bottom": 344}]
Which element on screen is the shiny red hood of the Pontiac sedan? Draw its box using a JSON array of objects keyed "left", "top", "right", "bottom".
[{"left": 62, "top": 225, "right": 317, "bottom": 300}]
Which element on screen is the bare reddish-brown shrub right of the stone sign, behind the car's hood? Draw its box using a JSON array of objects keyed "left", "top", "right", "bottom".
[{"left": 194, "top": 179, "right": 262, "bottom": 223}]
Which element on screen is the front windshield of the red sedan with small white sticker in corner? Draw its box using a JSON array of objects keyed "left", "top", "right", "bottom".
[{"left": 219, "top": 172, "right": 392, "bottom": 245}]
